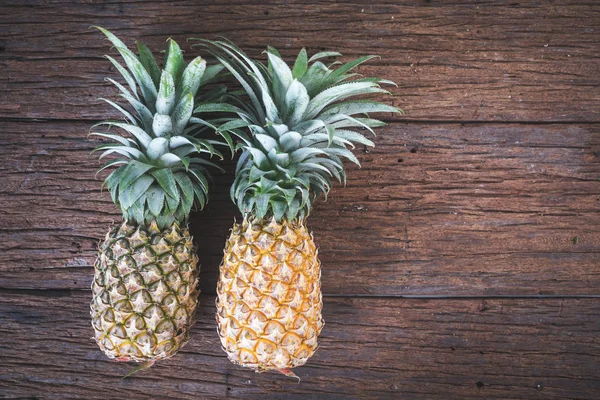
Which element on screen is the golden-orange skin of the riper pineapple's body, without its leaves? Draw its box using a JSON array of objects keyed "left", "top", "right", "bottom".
[{"left": 217, "top": 218, "right": 323, "bottom": 372}]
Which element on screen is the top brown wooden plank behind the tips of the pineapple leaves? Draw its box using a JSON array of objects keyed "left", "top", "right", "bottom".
[{"left": 0, "top": 0, "right": 600, "bottom": 121}]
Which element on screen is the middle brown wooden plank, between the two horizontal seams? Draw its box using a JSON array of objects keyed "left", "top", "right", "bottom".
[{"left": 0, "top": 122, "right": 600, "bottom": 296}]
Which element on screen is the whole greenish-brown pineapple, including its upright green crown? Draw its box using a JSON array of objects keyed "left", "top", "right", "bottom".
[{"left": 91, "top": 28, "right": 230, "bottom": 365}]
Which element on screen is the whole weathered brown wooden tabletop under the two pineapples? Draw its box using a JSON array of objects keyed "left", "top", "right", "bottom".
[{"left": 0, "top": 0, "right": 600, "bottom": 400}]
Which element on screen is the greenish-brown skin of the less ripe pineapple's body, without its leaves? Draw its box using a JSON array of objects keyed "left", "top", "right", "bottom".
[{"left": 90, "top": 222, "right": 198, "bottom": 362}]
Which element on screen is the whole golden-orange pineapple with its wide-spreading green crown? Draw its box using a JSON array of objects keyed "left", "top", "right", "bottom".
[{"left": 201, "top": 40, "right": 400, "bottom": 376}]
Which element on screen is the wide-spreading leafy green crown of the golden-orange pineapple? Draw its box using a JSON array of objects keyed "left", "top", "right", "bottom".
[{"left": 191, "top": 39, "right": 401, "bottom": 221}]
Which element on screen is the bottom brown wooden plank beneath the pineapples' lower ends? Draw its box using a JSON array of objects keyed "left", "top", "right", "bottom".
[{"left": 0, "top": 291, "right": 600, "bottom": 400}]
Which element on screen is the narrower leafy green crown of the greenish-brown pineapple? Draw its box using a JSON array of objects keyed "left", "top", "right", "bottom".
[{"left": 90, "top": 27, "right": 231, "bottom": 229}]
